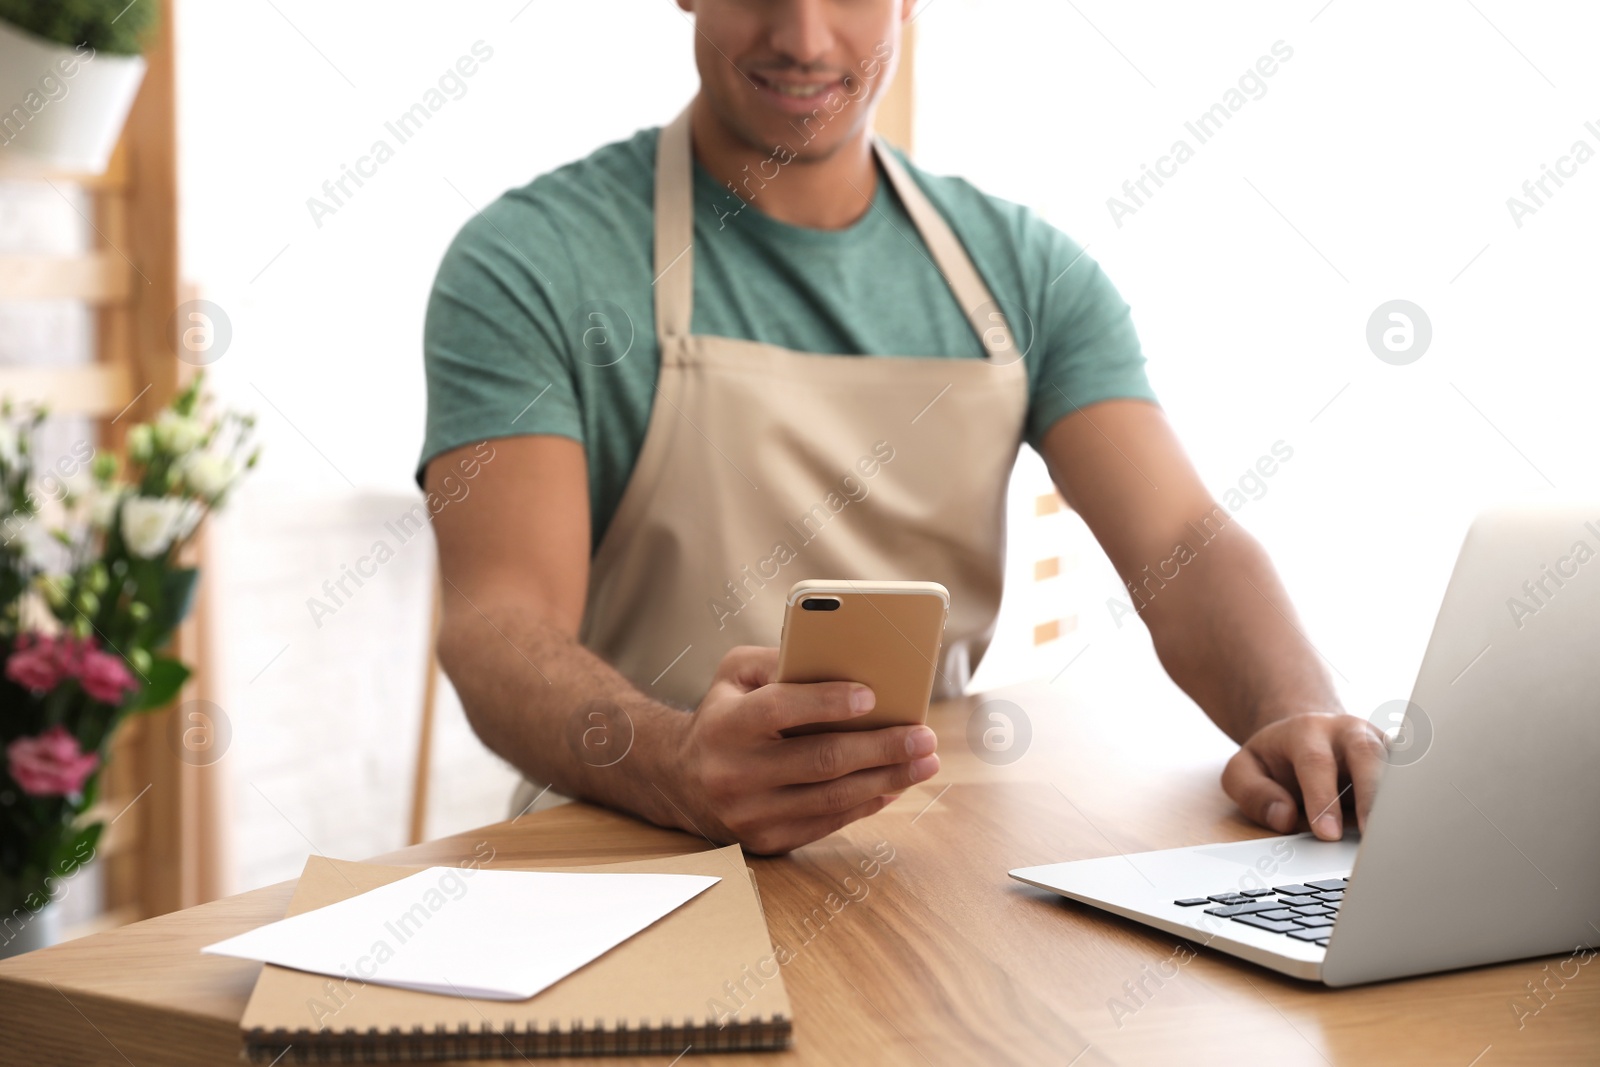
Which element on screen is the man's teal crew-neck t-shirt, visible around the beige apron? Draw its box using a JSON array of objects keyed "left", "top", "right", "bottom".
[{"left": 418, "top": 130, "right": 1155, "bottom": 547}]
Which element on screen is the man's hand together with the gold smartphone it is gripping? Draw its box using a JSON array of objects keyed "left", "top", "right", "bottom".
[{"left": 662, "top": 579, "right": 950, "bottom": 853}]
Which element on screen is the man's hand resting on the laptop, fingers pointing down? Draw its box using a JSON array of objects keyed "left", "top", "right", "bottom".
[{"left": 1222, "top": 712, "right": 1384, "bottom": 841}]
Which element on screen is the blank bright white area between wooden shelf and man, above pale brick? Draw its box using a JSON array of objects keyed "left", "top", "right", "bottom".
[{"left": 179, "top": 0, "right": 696, "bottom": 493}]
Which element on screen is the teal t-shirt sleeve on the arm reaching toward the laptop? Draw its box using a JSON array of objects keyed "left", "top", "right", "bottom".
[{"left": 1027, "top": 216, "right": 1155, "bottom": 448}]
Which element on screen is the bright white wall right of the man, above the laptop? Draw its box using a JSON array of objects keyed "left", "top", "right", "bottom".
[{"left": 917, "top": 0, "right": 1600, "bottom": 715}]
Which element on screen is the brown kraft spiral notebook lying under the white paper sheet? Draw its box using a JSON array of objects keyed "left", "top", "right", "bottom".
[{"left": 240, "top": 845, "right": 790, "bottom": 1064}]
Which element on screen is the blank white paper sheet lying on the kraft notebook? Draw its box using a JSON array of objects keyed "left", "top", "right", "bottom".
[{"left": 202, "top": 867, "right": 720, "bottom": 1000}]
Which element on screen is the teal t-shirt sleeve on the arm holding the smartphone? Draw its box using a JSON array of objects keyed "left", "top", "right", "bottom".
[{"left": 416, "top": 197, "right": 584, "bottom": 485}]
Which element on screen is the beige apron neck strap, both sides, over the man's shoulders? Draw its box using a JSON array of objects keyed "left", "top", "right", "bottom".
[{"left": 654, "top": 106, "right": 1016, "bottom": 356}]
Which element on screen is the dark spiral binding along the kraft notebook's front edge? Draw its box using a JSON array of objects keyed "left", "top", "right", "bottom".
[{"left": 245, "top": 1016, "right": 794, "bottom": 1064}]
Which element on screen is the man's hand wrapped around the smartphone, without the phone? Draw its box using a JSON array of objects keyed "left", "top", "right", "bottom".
[{"left": 672, "top": 646, "right": 939, "bottom": 854}]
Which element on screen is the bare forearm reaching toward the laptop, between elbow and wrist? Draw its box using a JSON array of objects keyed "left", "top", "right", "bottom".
[{"left": 1141, "top": 525, "right": 1339, "bottom": 742}]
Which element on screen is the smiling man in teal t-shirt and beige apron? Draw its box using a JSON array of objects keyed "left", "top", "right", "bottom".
[{"left": 422, "top": 0, "right": 1382, "bottom": 853}]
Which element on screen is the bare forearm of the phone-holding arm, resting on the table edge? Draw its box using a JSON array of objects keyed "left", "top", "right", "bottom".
[{"left": 438, "top": 598, "right": 690, "bottom": 829}]
